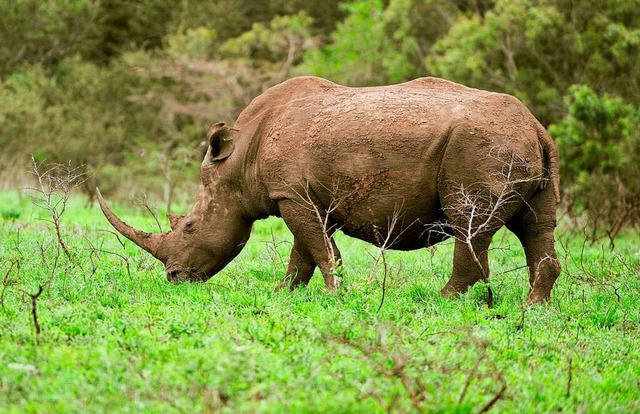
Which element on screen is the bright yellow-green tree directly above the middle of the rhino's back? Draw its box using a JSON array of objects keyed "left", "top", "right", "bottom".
[{"left": 302, "top": 0, "right": 458, "bottom": 86}]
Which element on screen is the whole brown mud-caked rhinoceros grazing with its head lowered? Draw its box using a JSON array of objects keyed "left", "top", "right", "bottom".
[{"left": 99, "top": 77, "right": 560, "bottom": 303}]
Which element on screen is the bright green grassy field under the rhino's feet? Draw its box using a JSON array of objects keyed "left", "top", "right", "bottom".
[{"left": 0, "top": 192, "right": 640, "bottom": 413}]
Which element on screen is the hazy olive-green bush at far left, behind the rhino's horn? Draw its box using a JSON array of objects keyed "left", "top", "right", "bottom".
[{"left": 0, "top": 57, "right": 204, "bottom": 202}]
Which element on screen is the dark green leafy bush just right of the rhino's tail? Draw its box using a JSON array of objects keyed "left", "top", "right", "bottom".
[{"left": 549, "top": 85, "right": 640, "bottom": 241}]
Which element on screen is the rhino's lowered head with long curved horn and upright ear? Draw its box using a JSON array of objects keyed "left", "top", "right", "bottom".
[{"left": 98, "top": 123, "right": 253, "bottom": 282}]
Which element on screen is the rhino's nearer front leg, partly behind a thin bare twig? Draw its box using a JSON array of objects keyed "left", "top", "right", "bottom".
[{"left": 278, "top": 200, "right": 341, "bottom": 290}]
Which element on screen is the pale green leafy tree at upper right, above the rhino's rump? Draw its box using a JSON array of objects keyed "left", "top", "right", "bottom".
[{"left": 427, "top": 0, "right": 640, "bottom": 125}]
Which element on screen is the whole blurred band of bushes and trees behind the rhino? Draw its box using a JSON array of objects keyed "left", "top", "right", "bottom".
[{"left": 0, "top": 0, "right": 640, "bottom": 233}]
